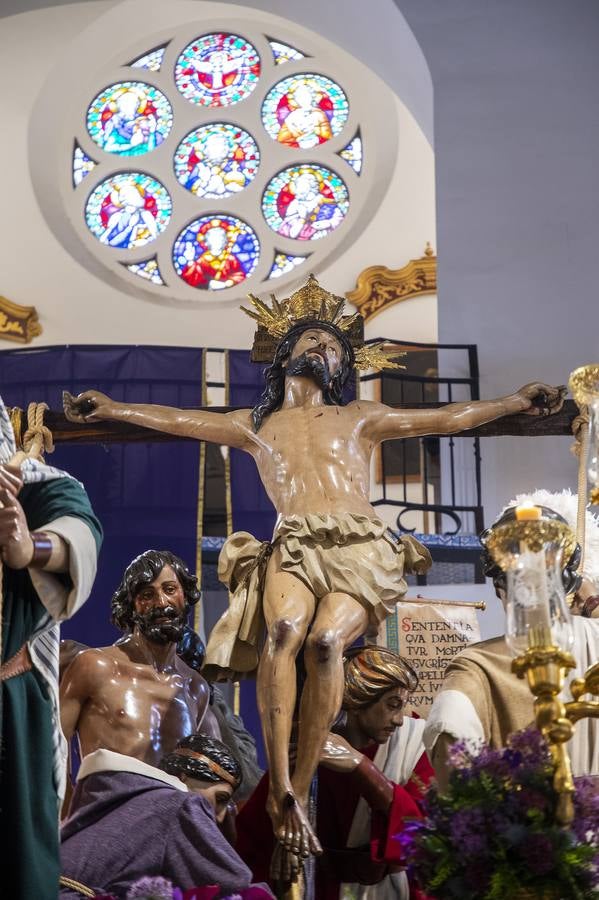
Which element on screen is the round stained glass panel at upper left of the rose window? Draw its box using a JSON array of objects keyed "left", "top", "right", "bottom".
[{"left": 87, "top": 81, "right": 173, "bottom": 156}]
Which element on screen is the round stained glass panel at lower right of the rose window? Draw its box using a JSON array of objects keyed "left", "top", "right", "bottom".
[{"left": 262, "top": 164, "right": 349, "bottom": 241}]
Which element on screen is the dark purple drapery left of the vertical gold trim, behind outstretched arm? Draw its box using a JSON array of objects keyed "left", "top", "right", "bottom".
[{"left": 0, "top": 346, "right": 202, "bottom": 647}]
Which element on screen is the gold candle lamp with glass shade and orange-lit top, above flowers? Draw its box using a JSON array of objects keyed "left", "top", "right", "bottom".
[{"left": 484, "top": 492, "right": 599, "bottom": 825}]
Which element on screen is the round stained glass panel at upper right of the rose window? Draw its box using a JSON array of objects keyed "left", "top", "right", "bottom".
[{"left": 262, "top": 74, "right": 349, "bottom": 150}]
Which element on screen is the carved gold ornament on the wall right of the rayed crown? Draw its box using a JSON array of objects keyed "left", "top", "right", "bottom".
[{"left": 345, "top": 244, "right": 437, "bottom": 322}]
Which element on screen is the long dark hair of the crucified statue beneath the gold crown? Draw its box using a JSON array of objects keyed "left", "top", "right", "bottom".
[{"left": 252, "top": 319, "right": 355, "bottom": 431}]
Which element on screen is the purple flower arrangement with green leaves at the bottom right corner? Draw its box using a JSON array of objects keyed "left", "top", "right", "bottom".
[{"left": 397, "top": 729, "right": 599, "bottom": 900}]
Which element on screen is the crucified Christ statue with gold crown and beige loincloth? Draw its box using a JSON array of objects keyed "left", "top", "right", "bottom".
[{"left": 65, "top": 276, "right": 564, "bottom": 855}]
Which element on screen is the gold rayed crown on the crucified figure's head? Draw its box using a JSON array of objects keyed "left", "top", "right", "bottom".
[{"left": 241, "top": 275, "right": 405, "bottom": 371}]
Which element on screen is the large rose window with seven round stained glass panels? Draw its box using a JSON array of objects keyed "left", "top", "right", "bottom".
[{"left": 71, "top": 30, "right": 380, "bottom": 300}]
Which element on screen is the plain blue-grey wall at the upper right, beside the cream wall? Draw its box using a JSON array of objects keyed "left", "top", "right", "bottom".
[{"left": 389, "top": 0, "right": 599, "bottom": 518}]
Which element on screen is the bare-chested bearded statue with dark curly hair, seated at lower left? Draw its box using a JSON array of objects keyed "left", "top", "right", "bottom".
[{"left": 60, "top": 550, "right": 210, "bottom": 766}]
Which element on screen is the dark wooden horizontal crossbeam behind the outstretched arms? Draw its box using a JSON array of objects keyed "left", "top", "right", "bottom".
[{"left": 23, "top": 400, "right": 578, "bottom": 444}]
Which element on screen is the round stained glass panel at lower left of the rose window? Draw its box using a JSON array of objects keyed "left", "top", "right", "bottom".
[{"left": 85, "top": 172, "right": 172, "bottom": 250}]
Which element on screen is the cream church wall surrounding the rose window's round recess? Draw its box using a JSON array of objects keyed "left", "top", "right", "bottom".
[{"left": 0, "top": 0, "right": 436, "bottom": 348}]
